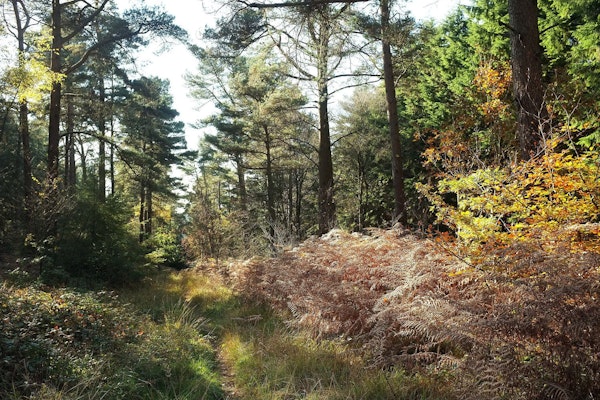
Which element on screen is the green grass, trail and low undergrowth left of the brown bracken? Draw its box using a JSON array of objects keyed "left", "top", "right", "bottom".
[{"left": 0, "top": 264, "right": 444, "bottom": 400}]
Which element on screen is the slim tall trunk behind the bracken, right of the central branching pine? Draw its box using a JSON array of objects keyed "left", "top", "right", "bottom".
[{"left": 380, "top": 0, "right": 407, "bottom": 224}]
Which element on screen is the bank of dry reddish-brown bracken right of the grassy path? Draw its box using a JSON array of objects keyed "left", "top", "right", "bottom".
[{"left": 226, "top": 230, "right": 600, "bottom": 399}]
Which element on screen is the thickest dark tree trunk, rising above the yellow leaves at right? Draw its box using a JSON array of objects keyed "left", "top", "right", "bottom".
[{"left": 508, "top": 0, "right": 550, "bottom": 160}]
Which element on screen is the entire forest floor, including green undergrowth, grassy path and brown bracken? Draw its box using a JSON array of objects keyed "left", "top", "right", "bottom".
[{"left": 0, "top": 230, "right": 600, "bottom": 400}]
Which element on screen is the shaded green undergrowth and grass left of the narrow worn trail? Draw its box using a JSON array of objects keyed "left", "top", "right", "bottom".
[{"left": 0, "top": 268, "right": 223, "bottom": 400}]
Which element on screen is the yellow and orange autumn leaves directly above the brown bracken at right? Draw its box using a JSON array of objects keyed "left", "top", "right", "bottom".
[{"left": 427, "top": 143, "right": 600, "bottom": 250}]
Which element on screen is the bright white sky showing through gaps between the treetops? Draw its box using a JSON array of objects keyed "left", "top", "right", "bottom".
[{"left": 121, "top": 0, "right": 469, "bottom": 149}]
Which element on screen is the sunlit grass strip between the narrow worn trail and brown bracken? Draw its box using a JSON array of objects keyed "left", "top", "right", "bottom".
[{"left": 159, "top": 271, "right": 445, "bottom": 400}]
